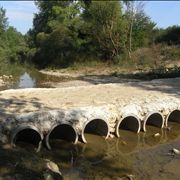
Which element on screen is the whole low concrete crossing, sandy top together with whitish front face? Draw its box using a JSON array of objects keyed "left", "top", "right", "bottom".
[{"left": 0, "top": 79, "right": 180, "bottom": 148}]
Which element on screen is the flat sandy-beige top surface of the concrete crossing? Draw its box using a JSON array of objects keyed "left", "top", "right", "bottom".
[{"left": 0, "top": 78, "right": 180, "bottom": 113}]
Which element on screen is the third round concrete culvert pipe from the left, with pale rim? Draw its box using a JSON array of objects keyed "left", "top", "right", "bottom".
[{"left": 81, "top": 119, "right": 109, "bottom": 143}]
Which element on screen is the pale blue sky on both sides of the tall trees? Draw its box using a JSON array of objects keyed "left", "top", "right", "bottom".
[{"left": 0, "top": 1, "right": 180, "bottom": 34}]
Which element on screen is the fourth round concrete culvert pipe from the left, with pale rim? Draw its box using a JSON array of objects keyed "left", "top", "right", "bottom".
[{"left": 116, "top": 115, "right": 141, "bottom": 137}]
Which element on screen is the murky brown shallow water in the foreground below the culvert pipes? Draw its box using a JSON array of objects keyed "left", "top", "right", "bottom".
[{"left": 0, "top": 122, "right": 180, "bottom": 180}]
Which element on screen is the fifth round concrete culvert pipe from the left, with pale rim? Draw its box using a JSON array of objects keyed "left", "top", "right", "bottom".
[{"left": 143, "top": 112, "right": 164, "bottom": 132}]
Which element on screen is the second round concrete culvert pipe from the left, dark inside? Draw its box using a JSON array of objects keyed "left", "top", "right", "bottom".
[{"left": 46, "top": 124, "right": 78, "bottom": 149}]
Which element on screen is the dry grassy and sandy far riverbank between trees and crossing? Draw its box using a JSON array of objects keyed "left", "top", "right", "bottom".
[{"left": 40, "top": 61, "right": 180, "bottom": 87}]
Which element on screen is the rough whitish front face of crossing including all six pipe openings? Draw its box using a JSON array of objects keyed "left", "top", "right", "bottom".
[{"left": 0, "top": 93, "right": 180, "bottom": 151}]
